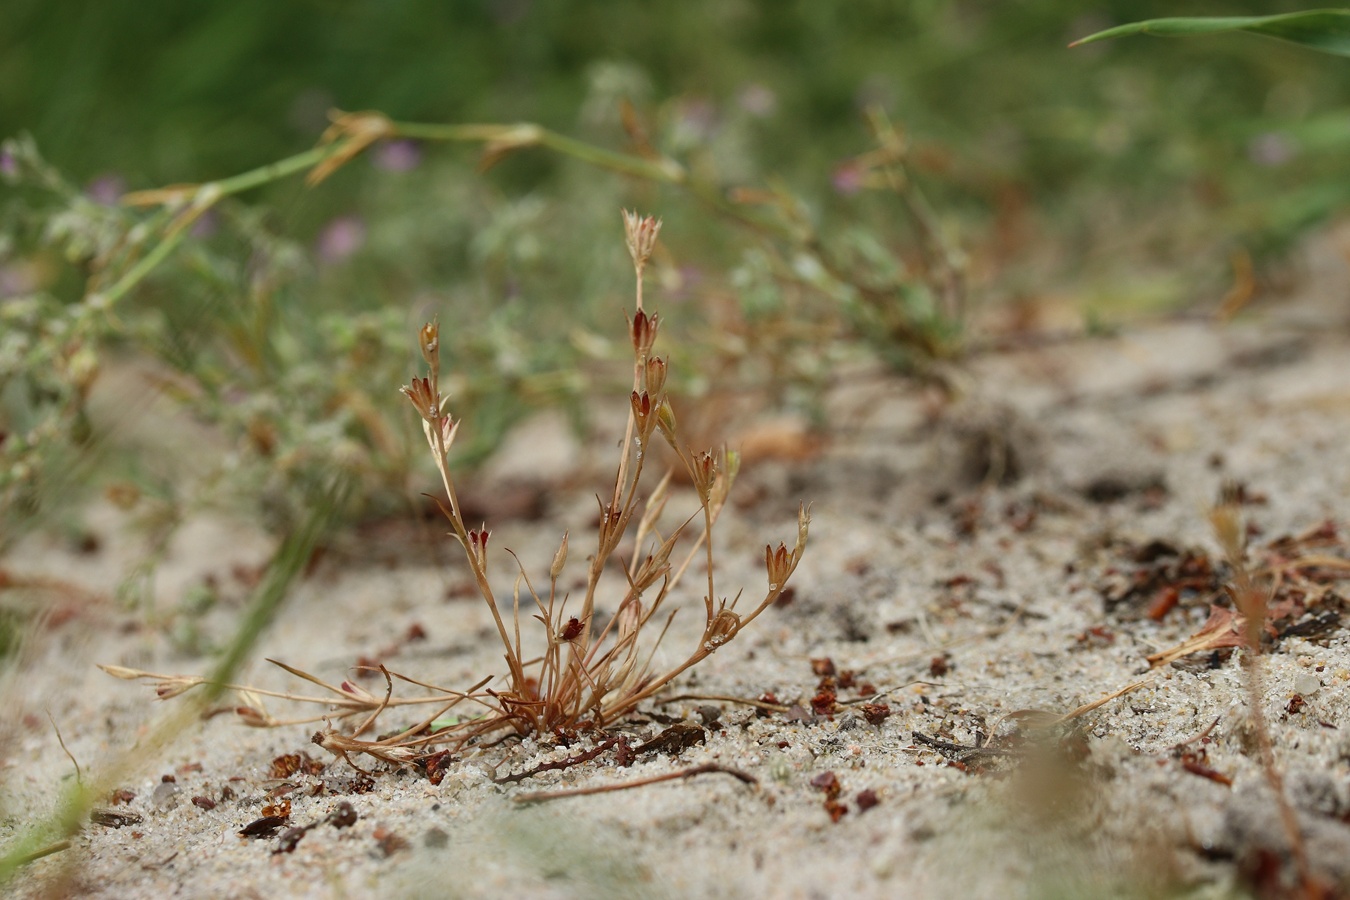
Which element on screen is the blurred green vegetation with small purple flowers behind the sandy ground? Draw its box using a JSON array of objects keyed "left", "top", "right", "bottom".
[{"left": 0, "top": 0, "right": 1350, "bottom": 549}]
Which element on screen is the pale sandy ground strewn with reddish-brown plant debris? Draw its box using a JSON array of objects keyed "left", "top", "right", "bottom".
[{"left": 0, "top": 236, "right": 1350, "bottom": 897}]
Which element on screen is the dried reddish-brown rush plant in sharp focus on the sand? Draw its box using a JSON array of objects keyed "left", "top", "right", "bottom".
[{"left": 103, "top": 212, "right": 810, "bottom": 765}]
